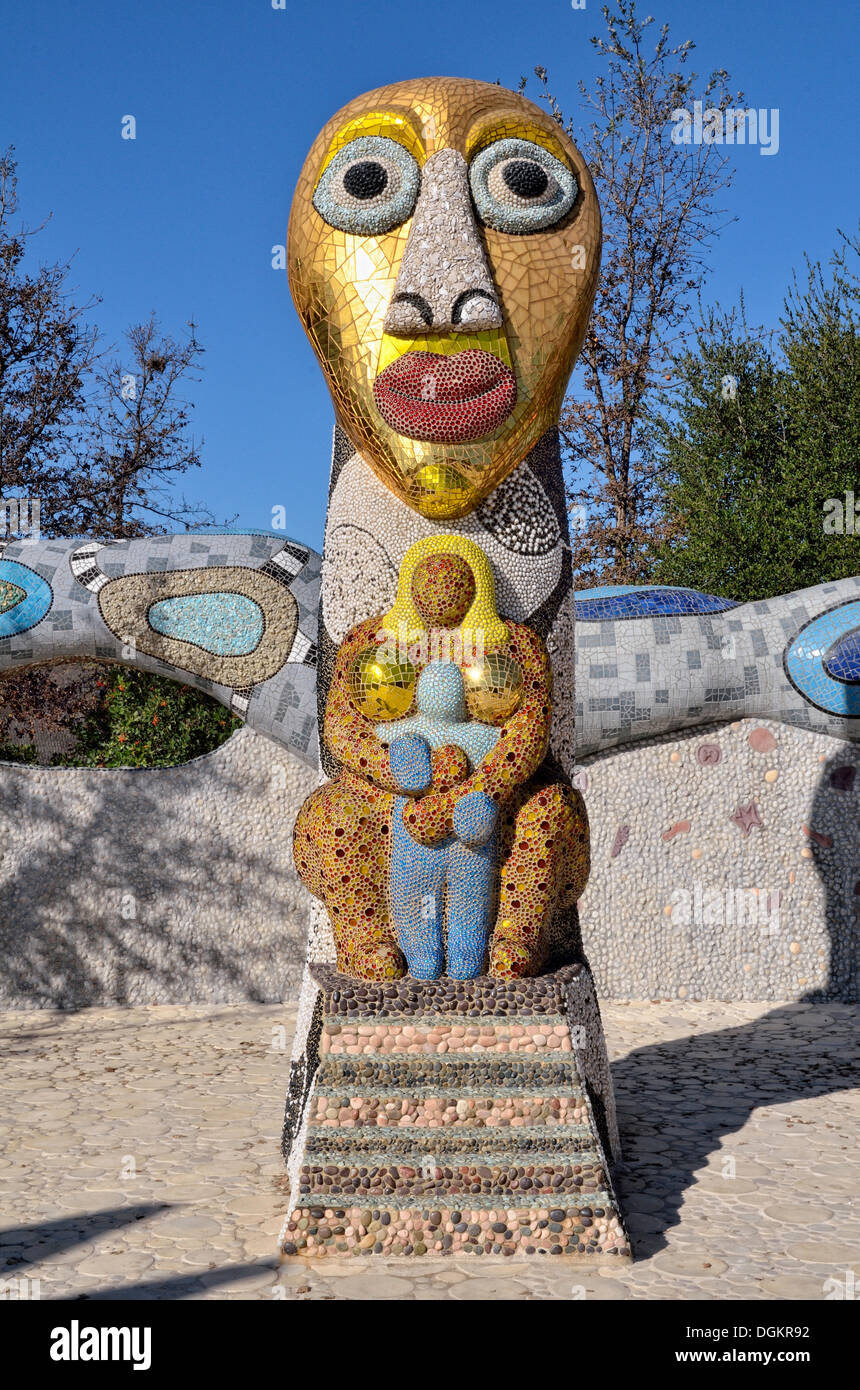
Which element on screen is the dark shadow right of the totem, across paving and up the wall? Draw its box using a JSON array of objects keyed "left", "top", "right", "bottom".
[{"left": 611, "top": 753, "right": 860, "bottom": 1259}]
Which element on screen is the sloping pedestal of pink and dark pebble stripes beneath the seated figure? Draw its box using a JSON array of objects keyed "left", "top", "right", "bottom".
[{"left": 282, "top": 966, "right": 629, "bottom": 1258}]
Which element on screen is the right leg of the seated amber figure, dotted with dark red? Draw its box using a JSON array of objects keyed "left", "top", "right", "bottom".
[{"left": 490, "top": 784, "right": 589, "bottom": 979}]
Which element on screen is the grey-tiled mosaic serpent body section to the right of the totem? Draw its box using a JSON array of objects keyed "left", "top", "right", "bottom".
[{"left": 575, "top": 578, "right": 860, "bottom": 756}]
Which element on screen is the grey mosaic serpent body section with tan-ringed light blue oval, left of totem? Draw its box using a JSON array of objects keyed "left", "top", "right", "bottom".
[{"left": 0, "top": 531, "right": 320, "bottom": 766}]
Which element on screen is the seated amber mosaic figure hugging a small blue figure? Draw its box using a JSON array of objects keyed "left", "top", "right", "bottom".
[{"left": 296, "top": 535, "right": 588, "bottom": 980}]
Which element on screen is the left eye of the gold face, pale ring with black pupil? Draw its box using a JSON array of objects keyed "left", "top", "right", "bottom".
[{"left": 314, "top": 135, "right": 421, "bottom": 236}]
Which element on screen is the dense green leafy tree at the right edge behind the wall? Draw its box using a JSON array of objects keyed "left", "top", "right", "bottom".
[{"left": 649, "top": 227, "right": 860, "bottom": 600}]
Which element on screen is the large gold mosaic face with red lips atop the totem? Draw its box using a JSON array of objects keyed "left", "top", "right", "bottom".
[{"left": 288, "top": 78, "right": 600, "bottom": 520}]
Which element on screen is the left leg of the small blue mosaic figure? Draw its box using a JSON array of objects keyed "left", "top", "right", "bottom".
[{"left": 389, "top": 796, "right": 445, "bottom": 980}]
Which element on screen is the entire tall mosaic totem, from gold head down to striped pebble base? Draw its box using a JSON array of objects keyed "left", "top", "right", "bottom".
[{"left": 283, "top": 78, "right": 629, "bottom": 1255}]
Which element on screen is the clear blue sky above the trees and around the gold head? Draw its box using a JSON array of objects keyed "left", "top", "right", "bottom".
[{"left": 0, "top": 0, "right": 860, "bottom": 546}]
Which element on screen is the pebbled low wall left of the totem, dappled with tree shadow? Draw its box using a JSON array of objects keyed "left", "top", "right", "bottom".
[{"left": 0, "top": 728, "right": 317, "bottom": 1009}]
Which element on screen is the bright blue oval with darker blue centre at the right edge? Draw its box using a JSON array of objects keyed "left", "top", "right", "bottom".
[{"left": 782, "top": 599, "right": 860, "bottom": 719}]
